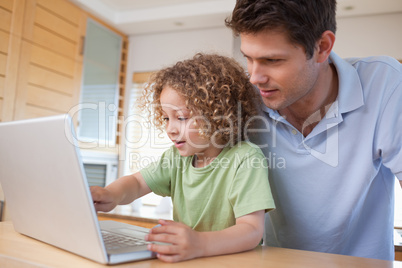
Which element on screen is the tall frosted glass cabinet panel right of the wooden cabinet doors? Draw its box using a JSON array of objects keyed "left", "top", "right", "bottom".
[{"left": 78, "top": 19, "right": 122, "bottom": 147}]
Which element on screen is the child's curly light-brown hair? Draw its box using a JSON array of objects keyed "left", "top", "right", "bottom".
[{"left": 140, "top": 53, "right": 259, "bottom": 145}]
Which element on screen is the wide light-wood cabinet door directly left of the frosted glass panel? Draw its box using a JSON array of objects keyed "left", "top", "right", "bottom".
[{"left": 13, "top": 0, "right": 86, "bottom": 120}]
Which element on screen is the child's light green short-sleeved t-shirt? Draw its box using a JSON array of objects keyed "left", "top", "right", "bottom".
[{"left": 140, "top": 142, "right": 275, "bottom": 231}]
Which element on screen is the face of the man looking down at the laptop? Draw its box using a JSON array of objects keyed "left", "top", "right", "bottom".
[{"left": 240, "top": 31, "right": 319, "bottom": 111}]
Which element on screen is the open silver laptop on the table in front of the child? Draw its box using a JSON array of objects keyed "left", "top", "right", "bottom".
[{"left": 0, "top": 115, "right": 155, "bottom": 264}]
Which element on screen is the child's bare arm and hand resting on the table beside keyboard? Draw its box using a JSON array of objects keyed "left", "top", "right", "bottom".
[{"left": 146, "top": 210, "right": 265, "bottom": 262}]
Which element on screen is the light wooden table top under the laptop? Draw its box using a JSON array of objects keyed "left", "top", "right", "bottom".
[{"left": 0, "top": 222, "right": 402, "bottom": 268}]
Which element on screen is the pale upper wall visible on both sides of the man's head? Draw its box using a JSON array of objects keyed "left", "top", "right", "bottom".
[{"left": 127, "top": 10, "right": 402, "bottom": 81}]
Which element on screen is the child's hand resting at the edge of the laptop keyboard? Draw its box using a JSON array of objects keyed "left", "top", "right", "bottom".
[{"left": 145, "top": 220, "right": 204, "bottom": 262}]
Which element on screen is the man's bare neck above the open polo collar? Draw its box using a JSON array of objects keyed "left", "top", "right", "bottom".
[{"left": 278, "top": 64, "right": 338, "bottom": 137}]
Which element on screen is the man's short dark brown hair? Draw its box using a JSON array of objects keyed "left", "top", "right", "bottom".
[{"left": 225, "top": 0, "right": 336, "bottom": 59}]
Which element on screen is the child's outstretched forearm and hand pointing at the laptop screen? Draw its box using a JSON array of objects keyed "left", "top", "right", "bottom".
[{"left": 91, "top": 172, "right": 151, "bottom": 211}]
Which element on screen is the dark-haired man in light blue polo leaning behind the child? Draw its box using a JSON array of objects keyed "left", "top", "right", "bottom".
[{"left": 226, "top": 0, "right": 402, "bottom": 260}]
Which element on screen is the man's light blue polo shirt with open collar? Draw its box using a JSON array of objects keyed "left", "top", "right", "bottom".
[{"left": 252, "top": 53, "right": 402, "bottom": 260}]
